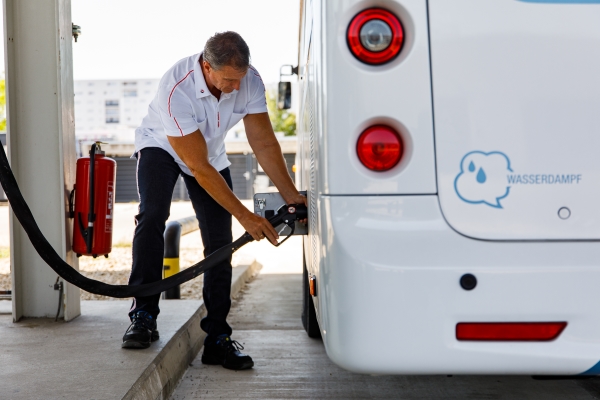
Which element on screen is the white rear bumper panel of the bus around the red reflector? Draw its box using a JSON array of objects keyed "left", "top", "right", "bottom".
[{"left": 316, "top": 196, "right": 600, "bottom": 375}]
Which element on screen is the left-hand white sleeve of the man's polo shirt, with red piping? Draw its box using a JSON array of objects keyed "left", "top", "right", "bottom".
[{"left": 158, "top": 83, "right": 198, "bottom": 136}]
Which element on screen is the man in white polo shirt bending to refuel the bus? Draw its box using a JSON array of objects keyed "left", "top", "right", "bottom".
[{"left": 122, "top": 32, "right": 306, "bottom": 370}]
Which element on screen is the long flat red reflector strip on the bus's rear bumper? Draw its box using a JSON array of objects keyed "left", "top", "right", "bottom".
[{"left": 456, "top": 322, "right": 567, "bottom": 341}]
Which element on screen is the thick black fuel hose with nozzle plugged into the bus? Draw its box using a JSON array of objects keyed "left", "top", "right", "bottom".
[{"left": 0, "top": 145, "right": 307, "bottom": 298}]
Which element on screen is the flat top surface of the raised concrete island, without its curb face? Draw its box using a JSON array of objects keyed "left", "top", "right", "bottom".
[{"left": 0, "top": 300, "right": 202, "bottom": 399}]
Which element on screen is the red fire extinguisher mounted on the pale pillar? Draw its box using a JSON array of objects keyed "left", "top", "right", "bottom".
[{"left": 70, "top": 142, "right": 117, "bottom": 257}]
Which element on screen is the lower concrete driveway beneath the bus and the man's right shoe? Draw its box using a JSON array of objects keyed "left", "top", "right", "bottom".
[{"left": 172, "top": 271, "right": 600, "bottom": 400}]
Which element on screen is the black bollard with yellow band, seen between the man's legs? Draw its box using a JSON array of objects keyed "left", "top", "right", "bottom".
[{"left": 162, "top": 217, "right": 198, "bottom": 299}]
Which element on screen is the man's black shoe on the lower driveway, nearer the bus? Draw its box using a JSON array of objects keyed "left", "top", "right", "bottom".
[{"left": 202, "top": 335, "right": 254, "bottom": 370}]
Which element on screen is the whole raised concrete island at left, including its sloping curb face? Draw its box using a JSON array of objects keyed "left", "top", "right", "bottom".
[{"left": 0, "top": 263, "right": 260, "bottom": 400}]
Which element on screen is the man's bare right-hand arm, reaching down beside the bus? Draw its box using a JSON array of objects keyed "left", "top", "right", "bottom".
[{"left": 244, "top": 113, "right": 306, "bottom": 205}]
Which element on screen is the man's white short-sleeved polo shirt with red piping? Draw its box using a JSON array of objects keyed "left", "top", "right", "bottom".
[{"left": 135, "top": 53, "right": 267, "bottom": 175}]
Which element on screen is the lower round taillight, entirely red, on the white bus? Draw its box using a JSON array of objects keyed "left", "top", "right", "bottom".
[{"left": 356, "top": 125, "right": 403, "bottom": 171}]
